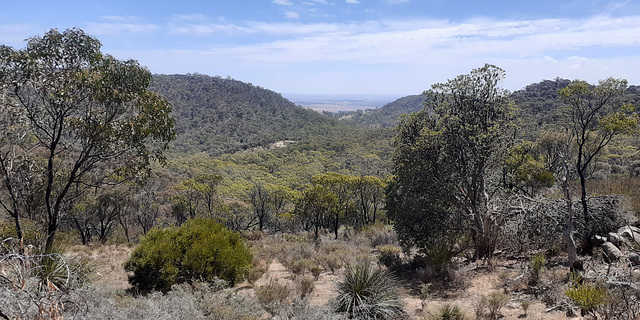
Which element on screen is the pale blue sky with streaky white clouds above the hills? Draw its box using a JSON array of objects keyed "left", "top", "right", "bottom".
[{"left": 0, "top": 0, "right": 640, "bottom": 95}]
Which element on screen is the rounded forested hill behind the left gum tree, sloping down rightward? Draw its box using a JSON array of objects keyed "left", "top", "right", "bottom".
[{"left": 150, "top": 74, "right": 344, "bottom": 155}]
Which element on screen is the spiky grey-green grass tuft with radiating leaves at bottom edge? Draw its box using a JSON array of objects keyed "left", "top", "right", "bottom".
[{"left": 336, "top": 262, "right": 406, "bottom": 319}]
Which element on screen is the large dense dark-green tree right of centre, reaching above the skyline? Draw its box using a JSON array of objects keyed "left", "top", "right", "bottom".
[{"left": 386, "top": 65, "right": 514, "bottom": 257}]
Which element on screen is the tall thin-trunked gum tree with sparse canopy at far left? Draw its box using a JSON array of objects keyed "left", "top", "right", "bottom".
[{"left": 0, "top": 29, "right": 175, "bottom": 252}]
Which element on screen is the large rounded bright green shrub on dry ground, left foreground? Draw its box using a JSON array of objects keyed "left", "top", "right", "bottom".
[{"left": 124, "top": 219, "right": 252, "bottom": 291}]
